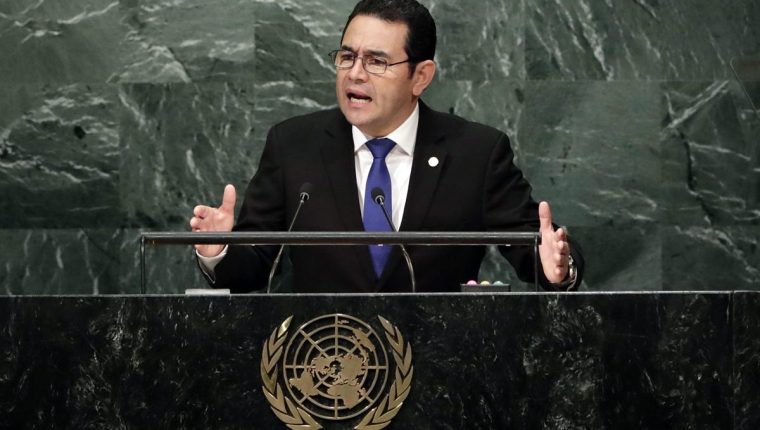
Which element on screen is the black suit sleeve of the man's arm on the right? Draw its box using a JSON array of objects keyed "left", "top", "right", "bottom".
[{"left": 483, "top": 133, "right": 584, "bottom": 291}]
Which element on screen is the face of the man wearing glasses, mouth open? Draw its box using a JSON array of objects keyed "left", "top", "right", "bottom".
[{"left": 335, "top": 15, "right": 417, "bottom": 137}]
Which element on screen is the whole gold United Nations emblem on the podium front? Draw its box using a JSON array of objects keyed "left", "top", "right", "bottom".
[{"left": 261, "top": 314, "right": 414, "bottom": 430}]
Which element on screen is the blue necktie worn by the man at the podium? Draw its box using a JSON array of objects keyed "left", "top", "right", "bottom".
[{"left": 364, "top": 139, "right": 396, "bottom": 278}]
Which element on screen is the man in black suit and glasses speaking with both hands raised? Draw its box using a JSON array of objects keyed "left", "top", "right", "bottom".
[{"left": 190, "top": 0, "right": 583, "bottom": 292}]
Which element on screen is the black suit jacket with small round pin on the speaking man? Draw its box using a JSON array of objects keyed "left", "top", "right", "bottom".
[{"left": 214, "top": 102, "right": 583, "bottom": 292}]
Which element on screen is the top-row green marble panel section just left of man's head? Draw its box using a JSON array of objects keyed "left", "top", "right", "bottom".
[{"left": 254, "top": 0, "right": 354, "bottom": 83}]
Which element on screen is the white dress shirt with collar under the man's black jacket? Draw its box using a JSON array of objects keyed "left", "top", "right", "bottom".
[{"left": 196, "top": 103, "right": 420, "bottom": 272}]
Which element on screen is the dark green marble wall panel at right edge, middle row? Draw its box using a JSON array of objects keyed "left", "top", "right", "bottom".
[{"left": 661, "top": 81, "right": 760, "bottom": 226}]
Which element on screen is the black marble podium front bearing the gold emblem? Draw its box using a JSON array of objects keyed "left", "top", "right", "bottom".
[{"left": 0, "top": 292, "right": 760, "bottom": 429}]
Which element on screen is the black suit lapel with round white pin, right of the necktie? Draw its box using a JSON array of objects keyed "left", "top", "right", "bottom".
[{"left": 380, "top": 100, "right": 447, "bottom": 287}]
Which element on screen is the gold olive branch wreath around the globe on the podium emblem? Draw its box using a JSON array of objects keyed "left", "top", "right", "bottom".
[{"left": 260, "top": 315, "right": 414, "bottom": 430}]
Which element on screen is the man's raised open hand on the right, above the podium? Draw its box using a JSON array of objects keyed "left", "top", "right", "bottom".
[{"left": 538, "top": 202, "right": 570, "bottom": 284}]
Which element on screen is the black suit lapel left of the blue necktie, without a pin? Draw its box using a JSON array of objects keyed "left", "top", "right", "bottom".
[{"left": 322, "top": 111, "right": 375, "bottom": 283}]
